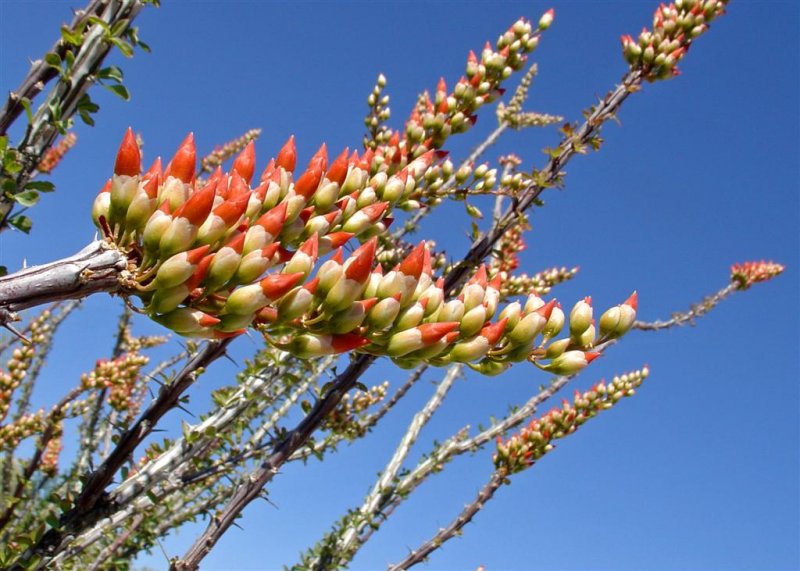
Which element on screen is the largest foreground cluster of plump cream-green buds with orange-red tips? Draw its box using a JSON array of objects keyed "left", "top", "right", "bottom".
[{"left": 92, "top": 125, "right": 635, "bottom": 368}]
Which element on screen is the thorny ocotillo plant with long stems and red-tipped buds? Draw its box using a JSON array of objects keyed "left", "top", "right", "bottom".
[{"left": 0, "top": 0, "right": 783, "bottom": 569}]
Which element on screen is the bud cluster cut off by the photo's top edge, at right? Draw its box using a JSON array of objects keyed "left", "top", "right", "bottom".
[{"left": 621, "top": 0, "right": 728, "bottom": 81}]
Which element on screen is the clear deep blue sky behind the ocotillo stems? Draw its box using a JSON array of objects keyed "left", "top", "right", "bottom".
[{"left": 0, "top": 0, "right": 800, "bottom": 571}]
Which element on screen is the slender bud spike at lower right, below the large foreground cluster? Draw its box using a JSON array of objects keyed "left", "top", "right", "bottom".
[{"left": 494, "top": 367, "right": 649, "bottom": 474}]
